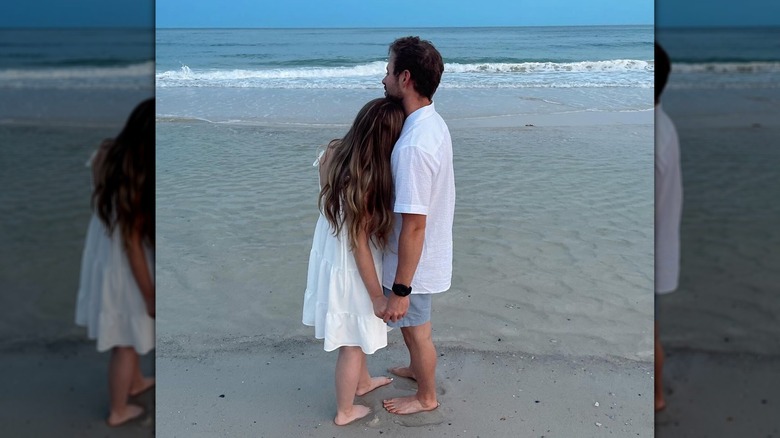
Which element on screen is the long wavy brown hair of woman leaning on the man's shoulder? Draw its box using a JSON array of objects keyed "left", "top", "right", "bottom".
[{"left": 319, "top": 98, "right": 404, "bottom": 249}]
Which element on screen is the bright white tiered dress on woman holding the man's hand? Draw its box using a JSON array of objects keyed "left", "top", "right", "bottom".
[{"left": 303, "top": 158, "right": 387, "bottom": 354}]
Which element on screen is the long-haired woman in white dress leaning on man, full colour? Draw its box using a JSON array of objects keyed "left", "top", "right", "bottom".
[{"left": 303, "top": 98, "right": 404, "bottom": 426}]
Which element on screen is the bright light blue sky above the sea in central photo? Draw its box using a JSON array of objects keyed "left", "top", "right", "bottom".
[{"left": 156, "top": 0, "right": 653, "bottom": 28}]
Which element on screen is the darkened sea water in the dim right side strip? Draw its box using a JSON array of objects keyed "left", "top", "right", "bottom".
[{"left": 657, "top": 27, "right": 780, "bottom": 356}]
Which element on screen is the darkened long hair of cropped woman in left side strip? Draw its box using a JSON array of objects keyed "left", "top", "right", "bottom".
[{"left": 92, "top": 99, "right": 154, "bottom": 246}]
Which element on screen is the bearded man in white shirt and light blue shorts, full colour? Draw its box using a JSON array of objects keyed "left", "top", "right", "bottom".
[{"left": 382, "top": 37, "right": 455, "bottom": 414}]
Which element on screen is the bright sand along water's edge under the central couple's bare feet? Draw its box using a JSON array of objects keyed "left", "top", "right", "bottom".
[{"left": 157, "top": 338, "right": 653, "bottom": 437}]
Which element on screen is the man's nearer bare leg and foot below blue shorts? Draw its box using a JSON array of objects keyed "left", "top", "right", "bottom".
[{"left": 383, "top": 321, "right": 439, "bottom": 414}]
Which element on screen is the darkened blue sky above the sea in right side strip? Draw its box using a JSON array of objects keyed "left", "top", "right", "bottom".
[{"left": 655, "top": 0, "right": 780, "bottom": 27}]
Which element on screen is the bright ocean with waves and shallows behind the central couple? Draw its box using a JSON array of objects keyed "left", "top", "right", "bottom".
[{"left": 155, "top": 26, "right": 653, "bottom": 361}]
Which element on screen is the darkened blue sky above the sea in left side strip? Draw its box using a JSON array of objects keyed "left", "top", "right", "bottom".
[{"left": 0, "top": 0, "right": 154, "bottom": 27}]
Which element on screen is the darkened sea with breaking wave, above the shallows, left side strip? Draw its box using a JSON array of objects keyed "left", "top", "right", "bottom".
[{"left": 0, "top": 29, "right": 154, "bottom": 125}]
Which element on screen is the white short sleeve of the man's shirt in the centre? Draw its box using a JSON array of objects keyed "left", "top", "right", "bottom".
[{"left": 393, "top": 146, "right": 436, "bottom": 216}]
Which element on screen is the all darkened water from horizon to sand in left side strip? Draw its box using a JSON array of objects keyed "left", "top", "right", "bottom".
[{"left": 0, "top": 29, "right": 154, "bottom": 345}]
